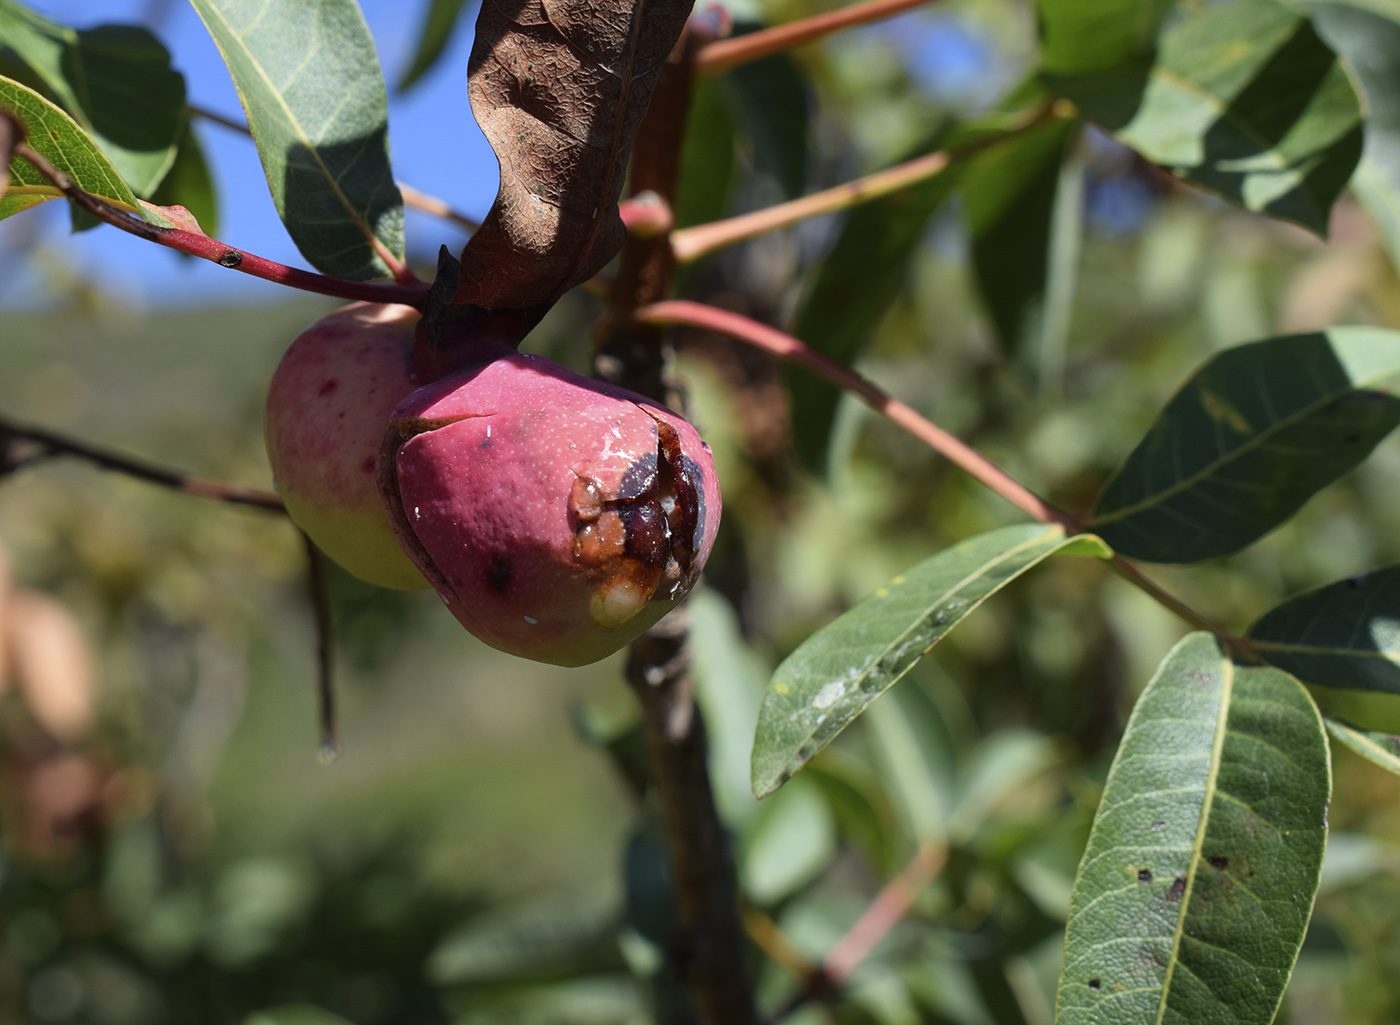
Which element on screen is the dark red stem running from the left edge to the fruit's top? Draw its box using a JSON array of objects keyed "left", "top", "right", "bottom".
[{"left": 14, "top": 143, "right": 428, "bottom": 307}]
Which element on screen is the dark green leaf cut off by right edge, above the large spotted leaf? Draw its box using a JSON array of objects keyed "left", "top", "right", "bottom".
[{"left": 1249, "top": 566, "right": 1400, "bottom": 695}]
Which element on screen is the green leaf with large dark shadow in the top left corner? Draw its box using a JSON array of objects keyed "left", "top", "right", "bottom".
[{"left": 0, "top": 0, "right": 185, "bottom": 199}]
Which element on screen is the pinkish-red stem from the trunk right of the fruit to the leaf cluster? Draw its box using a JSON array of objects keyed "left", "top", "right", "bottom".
[{"left": 636, "top": 300, "right": 1078, "bottom": 532}]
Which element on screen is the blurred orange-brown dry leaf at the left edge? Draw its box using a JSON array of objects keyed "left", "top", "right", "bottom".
[{"left": 4, "top": 591, "right": 95, "bottom": 742}]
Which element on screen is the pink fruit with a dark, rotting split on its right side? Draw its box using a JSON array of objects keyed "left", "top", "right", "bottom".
[{"left": 379, "top": 354, "right": 720, "bottom": 665}]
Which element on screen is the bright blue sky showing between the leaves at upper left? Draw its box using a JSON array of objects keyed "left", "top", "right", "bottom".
[{"left": 0, "top": 0, "right": 497, "bottom": 305}]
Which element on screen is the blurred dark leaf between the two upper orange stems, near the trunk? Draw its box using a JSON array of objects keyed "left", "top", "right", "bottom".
[{"left": 725, "top": 22, "right": 809, "bottom": 197}]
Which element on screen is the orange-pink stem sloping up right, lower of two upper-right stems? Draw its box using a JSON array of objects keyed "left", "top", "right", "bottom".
[{"left": 671, "top": 102, "right": 1058, "bottom": 263}]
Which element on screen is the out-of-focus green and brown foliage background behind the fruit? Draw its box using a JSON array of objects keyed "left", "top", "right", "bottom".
[{"left": 0, "top": 0, "right": 1400, "bottom": 1025}]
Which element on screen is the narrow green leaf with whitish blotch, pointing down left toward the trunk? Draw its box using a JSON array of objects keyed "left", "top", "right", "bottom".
[{"left": 752, "top": 524, "right": 1097, "bottom": 797}]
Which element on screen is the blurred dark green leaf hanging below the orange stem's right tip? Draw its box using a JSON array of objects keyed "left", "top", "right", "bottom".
[{"left": 960, "top": 120, "right": 1079, "bottom": 351}]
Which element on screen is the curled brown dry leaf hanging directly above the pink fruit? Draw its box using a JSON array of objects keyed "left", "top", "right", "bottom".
[{"left": 456, "top": 0, "right": 690, "bottom": 322}]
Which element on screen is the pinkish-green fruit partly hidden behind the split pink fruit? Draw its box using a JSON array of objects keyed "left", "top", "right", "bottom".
[{"left": 263, "top": 302, "right": 428, "bottom": 590}]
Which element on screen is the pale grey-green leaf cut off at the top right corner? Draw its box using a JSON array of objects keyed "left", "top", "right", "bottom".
[{"left": 1303, "top": 0, "right": 1400, "bottom": 267}]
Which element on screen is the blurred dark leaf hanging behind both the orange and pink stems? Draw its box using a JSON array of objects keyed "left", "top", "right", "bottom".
[{"left": 788, "top": 133, "right": 963, "bottom": 473}]
